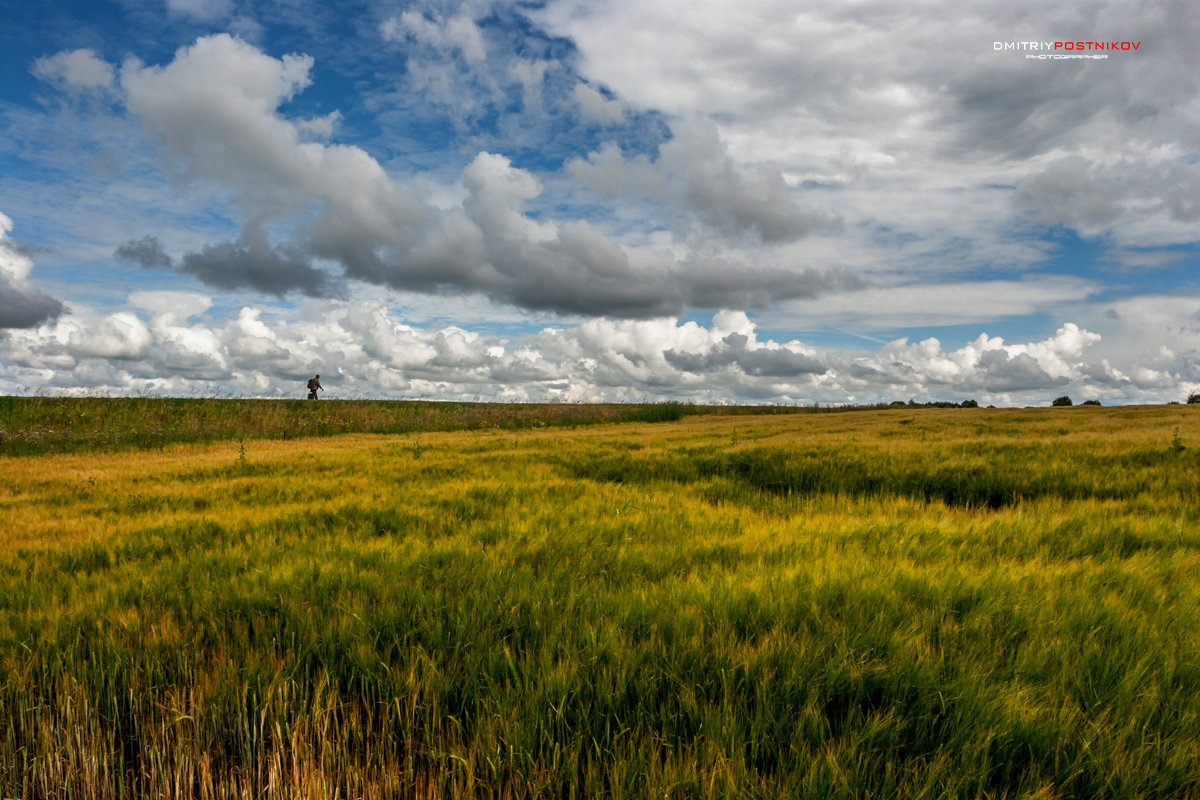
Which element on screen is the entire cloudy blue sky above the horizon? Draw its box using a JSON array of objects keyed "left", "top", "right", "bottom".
[{"left": 0, "top": 0, "right": 1200, "bottom": 407}]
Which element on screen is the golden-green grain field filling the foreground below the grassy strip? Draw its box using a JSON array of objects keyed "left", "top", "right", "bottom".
[{"left": 0, "top": 401, "right": 1200, "bottom": 800}]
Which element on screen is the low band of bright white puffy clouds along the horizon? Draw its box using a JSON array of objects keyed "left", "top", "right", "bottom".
[{"left": 0, "top": 286, "right": 1200, "bottom": 405}]
